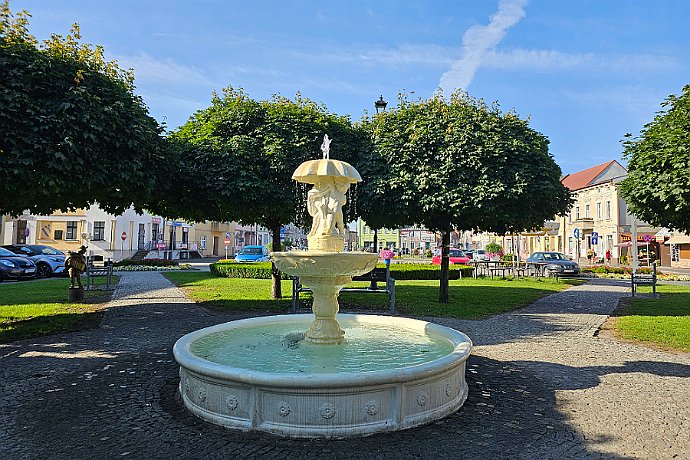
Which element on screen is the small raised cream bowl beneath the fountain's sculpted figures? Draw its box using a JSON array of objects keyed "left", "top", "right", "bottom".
[{"left": 271, "top": 251, "right": 379, "bottom": 278}]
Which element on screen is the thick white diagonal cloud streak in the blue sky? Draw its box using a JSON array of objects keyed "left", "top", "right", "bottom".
[{"left": 439, "top": 0, "right": 527, "bottom": 94}]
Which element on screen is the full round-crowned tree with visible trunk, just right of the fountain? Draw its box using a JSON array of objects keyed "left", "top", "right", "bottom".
[{"left": 356, "top": 92, "right": 571, "bottom": 303}]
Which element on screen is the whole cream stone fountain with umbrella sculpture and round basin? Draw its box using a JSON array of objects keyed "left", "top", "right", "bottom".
[{"left": 173, "top": 135, "right": 472, "bottom": 438}]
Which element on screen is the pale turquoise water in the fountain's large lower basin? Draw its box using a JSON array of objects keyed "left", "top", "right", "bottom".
[{"left": 191, "top": 320, "right": 453, "bottom": 374}]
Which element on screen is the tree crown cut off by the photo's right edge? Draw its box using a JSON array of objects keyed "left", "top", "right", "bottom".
[{"left": 621, "top": 85, "right": 690, "bottom": 233}]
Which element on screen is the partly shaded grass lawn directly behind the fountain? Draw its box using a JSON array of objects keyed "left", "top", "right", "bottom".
[{"left": 165, "top": 272, "right": 581, "bottom": 318}]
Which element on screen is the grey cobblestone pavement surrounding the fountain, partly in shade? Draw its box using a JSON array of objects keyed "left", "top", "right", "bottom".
[{"left": 0, "top": 272, "right": 690, "bottom": 459}]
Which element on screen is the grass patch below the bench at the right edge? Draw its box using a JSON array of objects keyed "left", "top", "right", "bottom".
[{"left": 612, "top": 284, "right": 690, "bottom": 352}]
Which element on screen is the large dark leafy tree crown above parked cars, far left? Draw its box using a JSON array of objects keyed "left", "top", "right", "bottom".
[{"left": 0, "top": 2, "right": 165, "bottom": 215}]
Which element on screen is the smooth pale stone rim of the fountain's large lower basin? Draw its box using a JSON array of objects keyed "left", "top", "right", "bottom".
[{"left": 173, "top": 314, "right": 473, "bottom": 388}]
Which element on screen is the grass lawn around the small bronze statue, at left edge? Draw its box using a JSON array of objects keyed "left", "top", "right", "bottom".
[{"left": 0, "top": 276, "right": 119, "bottom": 343}]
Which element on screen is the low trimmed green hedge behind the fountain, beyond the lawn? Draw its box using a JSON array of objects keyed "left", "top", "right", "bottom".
[{"left": 210, "top": 261, "right": 474, "bottom": 280}]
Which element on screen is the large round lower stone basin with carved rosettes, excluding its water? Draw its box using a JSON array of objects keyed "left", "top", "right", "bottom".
[{"left": 173, "top": 315, "right": 472, "bottom": 438}]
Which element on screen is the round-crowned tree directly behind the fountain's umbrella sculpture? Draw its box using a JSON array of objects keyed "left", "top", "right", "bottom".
[{"left": 159, "top": 87, "right": 366, "bottom": 298}]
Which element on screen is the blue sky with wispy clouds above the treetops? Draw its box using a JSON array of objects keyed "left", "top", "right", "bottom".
[{"left": 10, "top": 0, "right": 690, "bottom": 174}]
